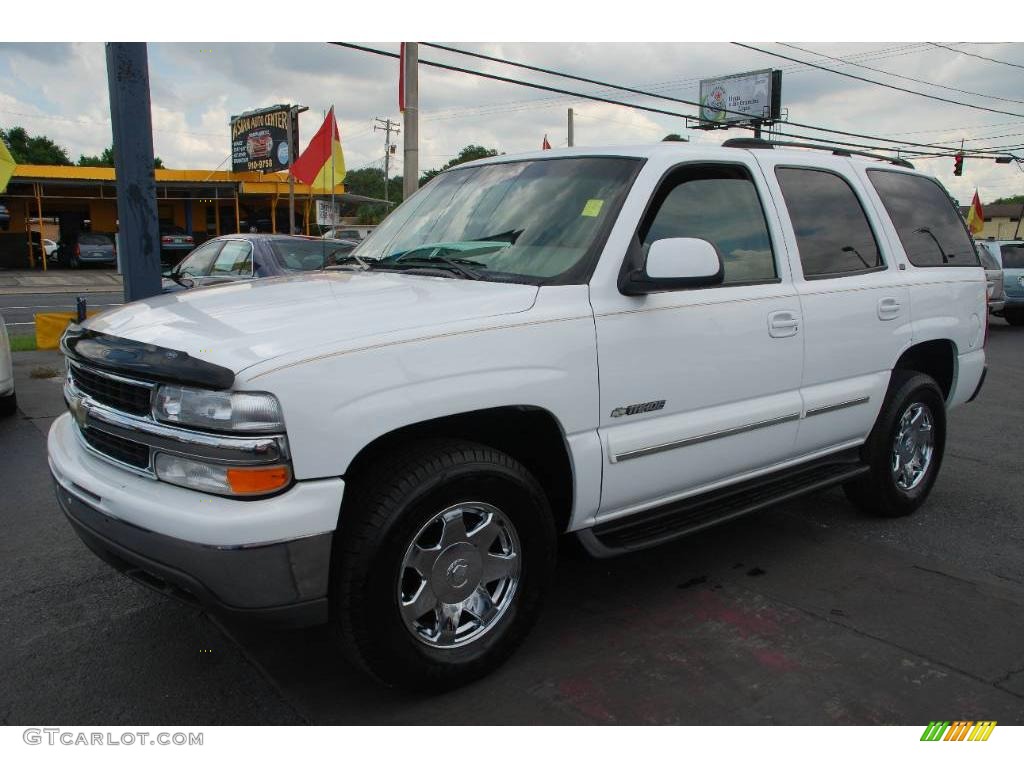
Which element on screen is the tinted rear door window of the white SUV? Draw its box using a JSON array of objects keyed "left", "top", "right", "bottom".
[{"left": 775, "top": 168, "right": 883, "bottom": 280}]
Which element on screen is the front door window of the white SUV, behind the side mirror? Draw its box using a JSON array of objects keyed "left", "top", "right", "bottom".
[{"left": 640, "top": 165, "right": 777, "bottom": 285}]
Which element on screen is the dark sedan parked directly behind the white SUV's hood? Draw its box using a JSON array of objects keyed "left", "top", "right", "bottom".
[{"left": 163, "top": 233, "right": 358, "bottom": 293}]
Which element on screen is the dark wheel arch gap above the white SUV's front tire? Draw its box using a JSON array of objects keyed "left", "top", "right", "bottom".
[{"left": 344, "top": 404, "right": 574, "bottom": 532}]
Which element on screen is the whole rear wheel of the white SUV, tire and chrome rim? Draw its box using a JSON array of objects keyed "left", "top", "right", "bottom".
[{"left": 843, "top": 371, "right": 946, "bottom": 517}]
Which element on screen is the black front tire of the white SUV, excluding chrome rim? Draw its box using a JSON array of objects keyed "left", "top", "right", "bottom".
[{"left": 331, "top": 439, "right": 557, "bottom": 692}]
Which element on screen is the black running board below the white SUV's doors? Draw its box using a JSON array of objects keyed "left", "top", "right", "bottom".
[{"left": 577, "top": 450, "right": 869, "bottom": 557}]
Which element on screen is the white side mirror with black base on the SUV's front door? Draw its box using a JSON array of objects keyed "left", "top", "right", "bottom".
[{"left": 618, "top": 238, "right": 725, "bottom": 296}]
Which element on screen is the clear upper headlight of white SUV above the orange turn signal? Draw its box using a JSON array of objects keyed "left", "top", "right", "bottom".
[{"left": 153, "top": 384, "right": 285, "bottom": 432}]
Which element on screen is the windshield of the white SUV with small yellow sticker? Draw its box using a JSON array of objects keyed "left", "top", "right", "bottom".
[{"left": 354, "top": 158, "right": 639, "bottom": 282}]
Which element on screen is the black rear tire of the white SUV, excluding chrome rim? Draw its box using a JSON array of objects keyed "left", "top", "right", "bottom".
[{"left": 843, "top": 371, "right": 946, "bottom": 517}]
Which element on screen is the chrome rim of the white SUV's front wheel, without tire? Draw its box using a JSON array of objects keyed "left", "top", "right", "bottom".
[{"left": 398, "top": 502, "right": 520, "bottom": 648}]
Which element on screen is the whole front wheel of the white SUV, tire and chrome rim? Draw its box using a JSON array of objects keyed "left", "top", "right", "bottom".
[{"left": 331, "top": 440, "right": 556, "bottom": 691}]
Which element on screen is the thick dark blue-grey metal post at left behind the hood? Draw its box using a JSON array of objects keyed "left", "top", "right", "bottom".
[{"left": 104, "top": 43, "right": 160, "bottom": 301}]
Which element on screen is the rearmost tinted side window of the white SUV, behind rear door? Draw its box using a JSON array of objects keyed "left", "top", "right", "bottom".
[{"left": 867, "top": 170, "right": 979, "bottom": 266}]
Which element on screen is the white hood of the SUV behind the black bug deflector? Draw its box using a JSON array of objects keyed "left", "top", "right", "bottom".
[{"left": 84, "top": 271, "right": 538, "bottom": 373}]
